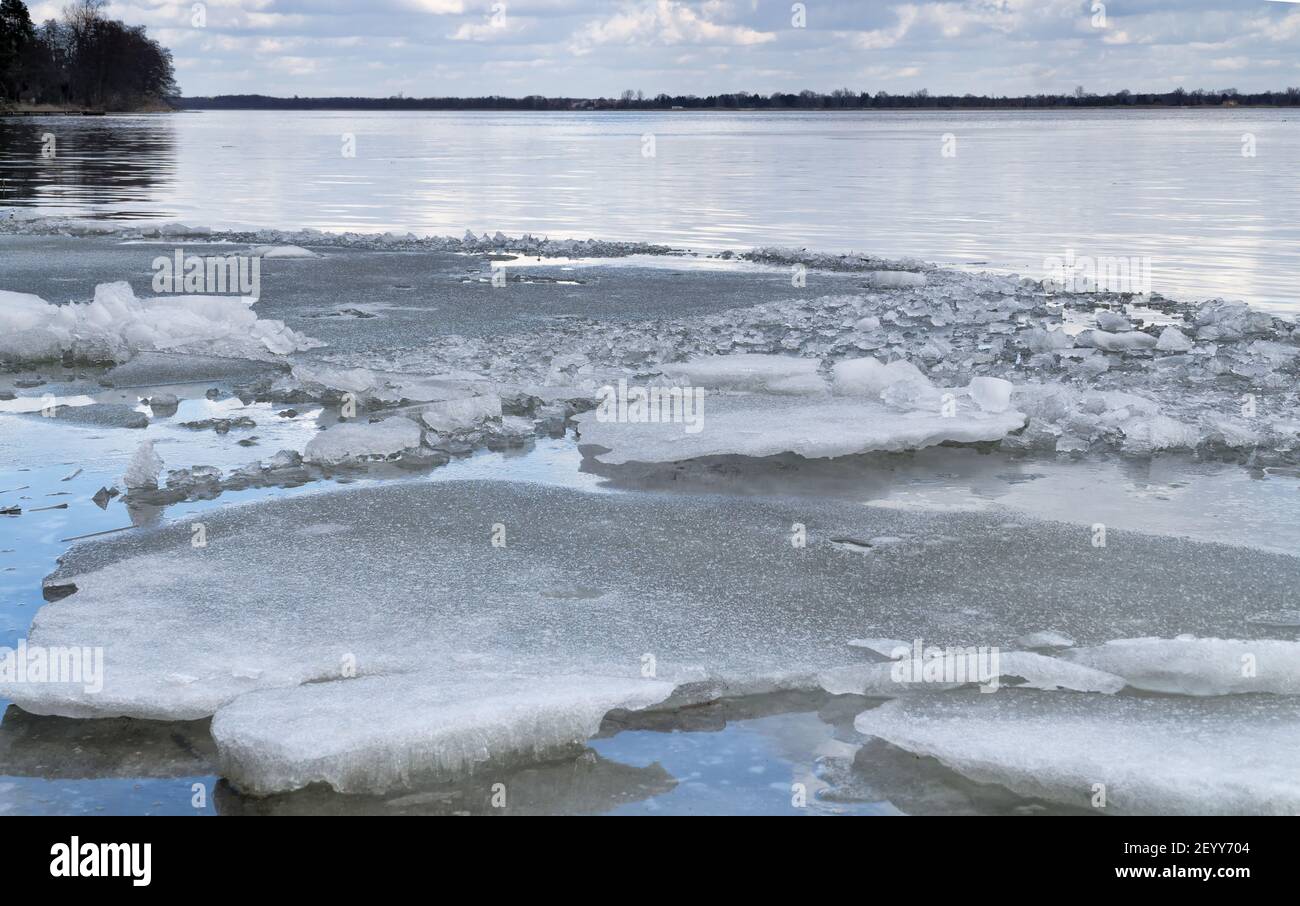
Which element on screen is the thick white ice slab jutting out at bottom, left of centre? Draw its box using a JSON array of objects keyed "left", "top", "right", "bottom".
[{"left": 212, "top": 675, "right": 672, "bottom": 793}]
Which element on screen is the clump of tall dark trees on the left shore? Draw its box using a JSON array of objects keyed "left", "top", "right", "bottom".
[{"left": 0, "top": 0, "right": 179, "bottom": 110}]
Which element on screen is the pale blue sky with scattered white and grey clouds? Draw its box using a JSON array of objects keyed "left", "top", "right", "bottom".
[{"left": 29, "top": 0, "right": 1300, "bottom": 97}]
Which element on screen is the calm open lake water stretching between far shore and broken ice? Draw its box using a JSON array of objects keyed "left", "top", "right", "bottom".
[{"left": 0, "top": 109, "right": 1300, "bottom": 311}]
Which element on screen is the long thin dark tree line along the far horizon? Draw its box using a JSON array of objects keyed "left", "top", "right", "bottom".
[{"left": 180, "top": 88, "right": 1300, "bottom": 110}]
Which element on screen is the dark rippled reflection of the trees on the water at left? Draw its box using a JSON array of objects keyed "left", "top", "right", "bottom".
[{"left": 0, "top": 116, "right": 177, "bottom": 220}]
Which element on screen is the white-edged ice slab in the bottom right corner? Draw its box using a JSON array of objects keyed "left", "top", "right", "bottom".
[{"left": 854, "top": 692, "right": 1300, "bottom": 815}]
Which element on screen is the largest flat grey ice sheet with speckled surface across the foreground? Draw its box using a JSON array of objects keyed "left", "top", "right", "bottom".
[{"left": 0, "top": 480, "right": 1300, "bottom": 764}]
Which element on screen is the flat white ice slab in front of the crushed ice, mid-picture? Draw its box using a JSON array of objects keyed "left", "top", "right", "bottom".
[{"left": 577, "top": 394, "right": 1024, "bottom": 465}]
